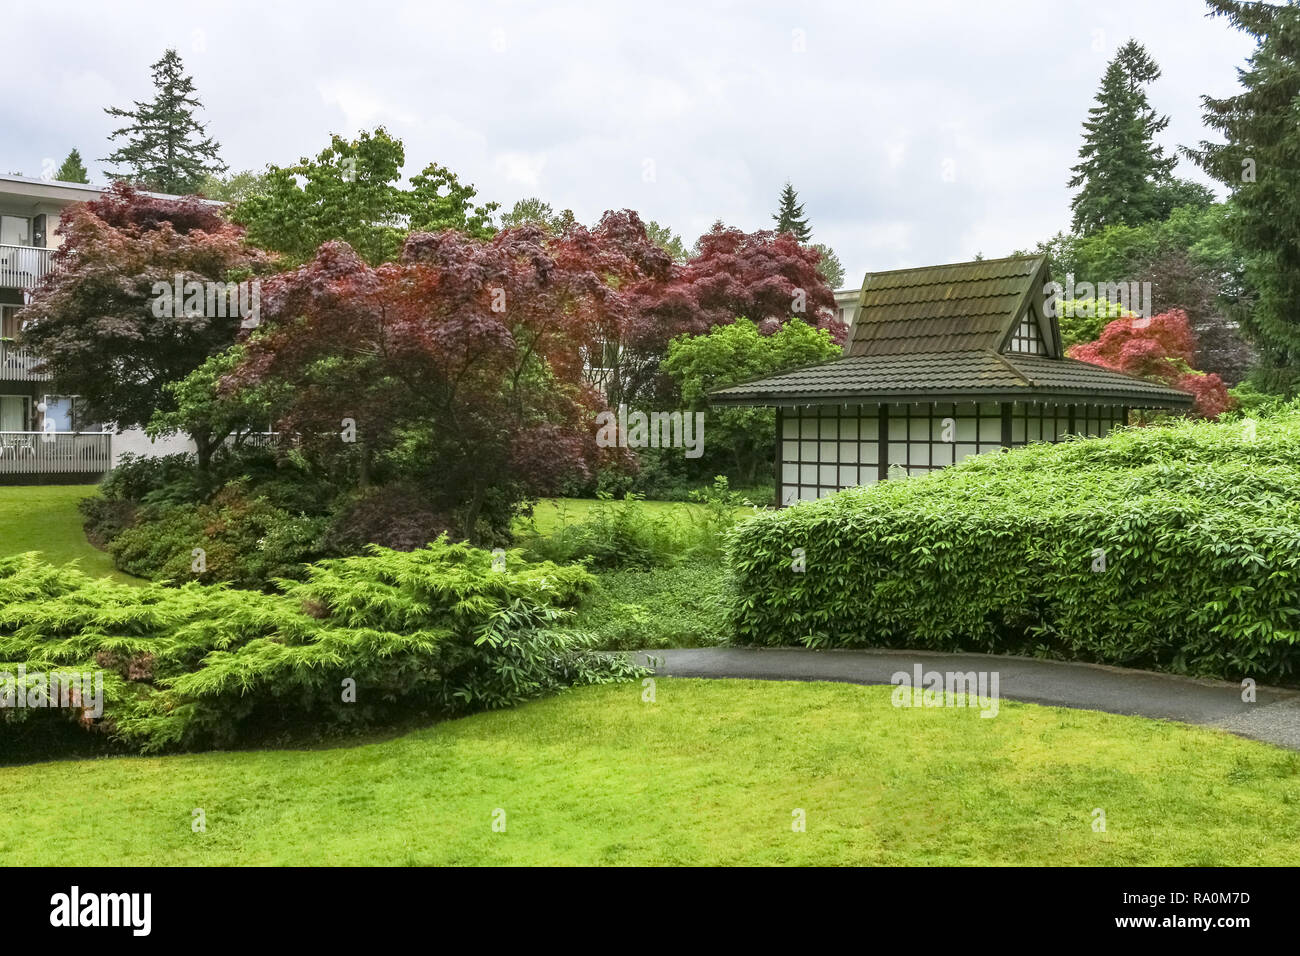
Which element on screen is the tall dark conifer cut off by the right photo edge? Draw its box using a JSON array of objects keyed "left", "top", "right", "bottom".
[{"left": 1183, "top": 0, "right": 1300, "bottom": 394}]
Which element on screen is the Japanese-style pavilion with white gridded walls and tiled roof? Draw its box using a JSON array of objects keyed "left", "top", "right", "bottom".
[{"left": 712, "top": 256, "right": 1192, "bottom": 505}]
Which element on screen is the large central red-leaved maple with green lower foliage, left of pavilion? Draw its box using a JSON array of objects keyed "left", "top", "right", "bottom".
[{"left": 225, "top": 226, "right": 613, "bottom": 541}]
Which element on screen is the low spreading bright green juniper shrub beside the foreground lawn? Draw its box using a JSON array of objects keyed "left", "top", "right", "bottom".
[{"left": 0, "top": 540, "right": 642, "bottom": 752}]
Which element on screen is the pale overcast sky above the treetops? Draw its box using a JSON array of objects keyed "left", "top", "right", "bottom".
[{"left": 0, "top": 0, "right": 1251, "bottom": 285}]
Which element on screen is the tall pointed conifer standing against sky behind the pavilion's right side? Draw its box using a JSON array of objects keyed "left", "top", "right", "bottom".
[{"left": 1069, "top": 40, "right": 1178, "bottom": 234}]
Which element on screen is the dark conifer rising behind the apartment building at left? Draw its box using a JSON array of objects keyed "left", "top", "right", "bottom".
[{"left": 104, "top": 49, "right": 226, "bottom": 195}]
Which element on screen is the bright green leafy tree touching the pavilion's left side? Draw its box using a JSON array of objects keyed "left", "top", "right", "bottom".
[{"left": 663, "top": 319, "right": 840, "bottom": 486}]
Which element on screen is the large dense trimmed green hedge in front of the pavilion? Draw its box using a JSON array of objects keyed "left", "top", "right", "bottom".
[{"left": 729, "top": 407, "right": 1300, "bottom": 683}]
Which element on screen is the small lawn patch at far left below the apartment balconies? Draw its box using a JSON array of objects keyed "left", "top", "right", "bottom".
[{"left": 0, "top": 485, "right": 137, "bottom": 583}]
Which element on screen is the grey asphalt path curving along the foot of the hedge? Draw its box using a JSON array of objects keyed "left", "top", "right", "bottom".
[{"left": 634, "top": 648, "right": 1300, "bottom": 750}]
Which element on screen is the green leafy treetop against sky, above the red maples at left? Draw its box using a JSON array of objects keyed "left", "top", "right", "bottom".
[{"left": 231, "top": 126, "right": 498, "bottom": 264}]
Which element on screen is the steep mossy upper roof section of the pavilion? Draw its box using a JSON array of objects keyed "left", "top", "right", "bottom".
[{"left": 845, "top": 256, "right": 1047, "bottom": 356}]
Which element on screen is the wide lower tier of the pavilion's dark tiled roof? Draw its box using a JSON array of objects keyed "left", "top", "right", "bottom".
[{"left": 711, "top": 349, "right": 1192, "bottom": 408}]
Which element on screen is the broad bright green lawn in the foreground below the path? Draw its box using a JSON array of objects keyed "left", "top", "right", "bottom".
[{"left": 0, "top": 679, "right": 1300, "bottom": 865}]
